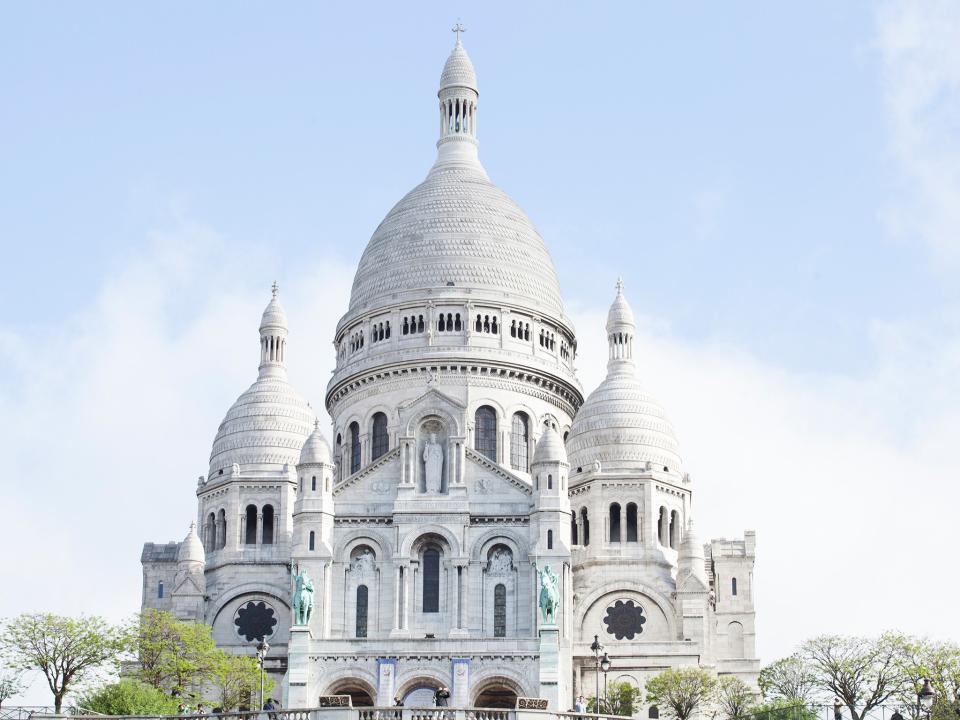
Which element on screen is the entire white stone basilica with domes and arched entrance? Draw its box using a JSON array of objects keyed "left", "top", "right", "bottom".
[{"left": 141, "top": 35, "right": 759, "bottom": 718}]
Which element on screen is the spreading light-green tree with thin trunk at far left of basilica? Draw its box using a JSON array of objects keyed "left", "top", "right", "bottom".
[{"left": 0, "top": 613, "right": 127, "bottom": 713}]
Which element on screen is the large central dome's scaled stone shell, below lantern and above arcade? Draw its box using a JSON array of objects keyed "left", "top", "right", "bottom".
[{"left": 350, "top": 162, "right": 565, "bottom": 319}]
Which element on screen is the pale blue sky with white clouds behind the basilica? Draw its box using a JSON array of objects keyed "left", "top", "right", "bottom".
[{"left": 0, "top": 0, "right": 960, "bottom": 702}]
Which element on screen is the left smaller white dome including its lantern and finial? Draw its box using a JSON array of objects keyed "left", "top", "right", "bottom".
[{"left": 208, "top": 286, "right": 316, "bottom": 480}]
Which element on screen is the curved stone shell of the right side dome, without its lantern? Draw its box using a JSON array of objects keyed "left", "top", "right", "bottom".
[{"left": 567, "top": 373, "right": 681, "bottom": 473}]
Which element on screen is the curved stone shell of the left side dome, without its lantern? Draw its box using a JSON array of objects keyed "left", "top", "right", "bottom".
[{"left": 209, "top": 375, "right": 316, "bottom": 480}]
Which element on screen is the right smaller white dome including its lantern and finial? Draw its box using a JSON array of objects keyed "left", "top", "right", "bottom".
[{"left": 567, "top": 281, "right": 682, "bottom": 474}]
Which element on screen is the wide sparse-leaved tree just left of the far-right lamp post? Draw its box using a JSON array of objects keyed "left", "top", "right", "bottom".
[{"left": 800, "top": 633, "right": 909, "bottom": 720}]
